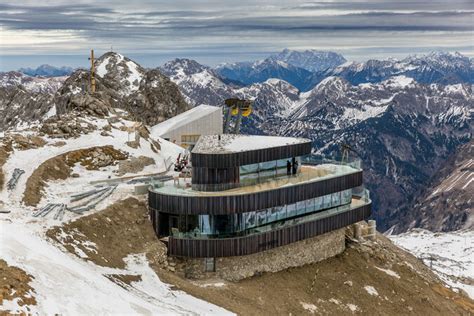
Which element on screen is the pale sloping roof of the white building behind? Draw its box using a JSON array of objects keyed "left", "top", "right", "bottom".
[{"left": 151, "top": 104, "right": 222, "bottom": 138}]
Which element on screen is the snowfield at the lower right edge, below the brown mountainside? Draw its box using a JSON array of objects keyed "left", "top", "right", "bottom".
[{"left": 389, "top": 229, "right": 474, "bottom": 299}]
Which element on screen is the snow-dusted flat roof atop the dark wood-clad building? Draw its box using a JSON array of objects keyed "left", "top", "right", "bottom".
[{"left": 192, "top": 134, "right": 311, "bottom": 154}]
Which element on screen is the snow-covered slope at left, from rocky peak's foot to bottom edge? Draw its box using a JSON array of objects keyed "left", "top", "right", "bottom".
[{"left": 0, "top": 110, "right": 232, "bottom": 315}]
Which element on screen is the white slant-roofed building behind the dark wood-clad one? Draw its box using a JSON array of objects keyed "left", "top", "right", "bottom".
[{"left": 151, "top": 105, "right": 223, "bottom": 148}]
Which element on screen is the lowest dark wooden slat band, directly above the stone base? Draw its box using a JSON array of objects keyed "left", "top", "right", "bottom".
[{"left": 168, "top": 204, "right": 371, "bottom": 258}]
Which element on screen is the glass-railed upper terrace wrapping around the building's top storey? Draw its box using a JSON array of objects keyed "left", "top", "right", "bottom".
[{"left": 153, "top": 155, "right": 361, "bottom": 196}]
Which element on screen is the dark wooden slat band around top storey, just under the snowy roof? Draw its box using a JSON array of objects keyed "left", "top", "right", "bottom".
[{"left": 191, "top": 140, "right": 311, "bottom": 168}]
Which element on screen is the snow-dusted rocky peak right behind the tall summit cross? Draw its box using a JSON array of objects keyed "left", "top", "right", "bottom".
[{"left": 55, "top": 53, "right": 188, "bottom": 125}]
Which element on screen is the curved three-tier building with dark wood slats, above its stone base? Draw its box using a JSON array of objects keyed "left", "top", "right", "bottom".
[{"left": 149, "top": 134, "right": 371, "bottom": 258}]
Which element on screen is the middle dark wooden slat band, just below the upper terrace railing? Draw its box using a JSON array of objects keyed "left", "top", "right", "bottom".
[{"left": 148, "top": 171, "right": 362, "bottom": 215}]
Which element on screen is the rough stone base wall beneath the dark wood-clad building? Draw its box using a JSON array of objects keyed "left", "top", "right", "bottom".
[{"left": 182, "top": 228, "right": 345, "bottom": 281}]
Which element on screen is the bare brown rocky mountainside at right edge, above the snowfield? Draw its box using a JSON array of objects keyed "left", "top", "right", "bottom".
[{"left": 394, "top": 140, "right": 474, "bottom": 232}]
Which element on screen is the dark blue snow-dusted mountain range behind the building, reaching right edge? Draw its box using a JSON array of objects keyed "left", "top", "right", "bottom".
[{"left": 160, "top": 55, "right": 473, "bottom": 229}]
